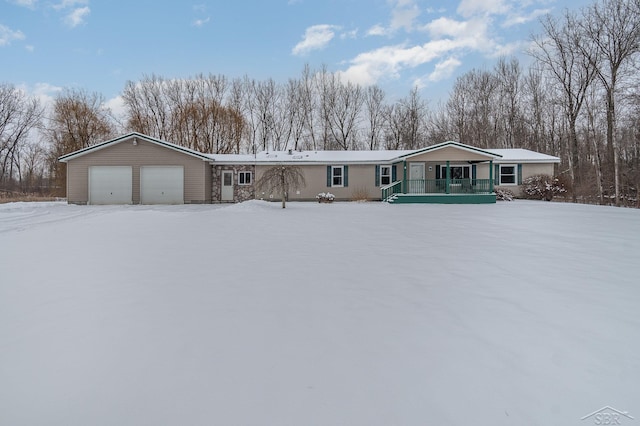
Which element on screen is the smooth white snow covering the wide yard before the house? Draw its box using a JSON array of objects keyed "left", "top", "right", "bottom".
[{"left": 0, "top": 201, "right": 640, "bottom": 426}]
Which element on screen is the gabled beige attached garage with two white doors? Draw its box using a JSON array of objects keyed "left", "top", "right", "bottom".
[{"left": 59, "top": 133, "right": 213, "bottom": 204}]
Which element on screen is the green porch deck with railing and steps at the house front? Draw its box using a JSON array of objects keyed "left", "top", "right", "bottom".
[{"left": 381, "top": 179, "right": 496, "bottom": 204}]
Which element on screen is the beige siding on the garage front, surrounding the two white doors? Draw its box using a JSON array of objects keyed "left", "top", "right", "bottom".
[{"left": 67, "top": 137, "right": 211, "bottom": 204}]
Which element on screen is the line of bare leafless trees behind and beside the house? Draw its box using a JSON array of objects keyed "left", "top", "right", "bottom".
[{"left": 0, "top": 0, "right": 640, "bottom": 205}]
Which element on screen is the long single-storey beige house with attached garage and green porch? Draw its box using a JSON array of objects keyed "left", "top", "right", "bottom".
[{"left": 59, "top": 133, "right": 560, "bottom": 204}]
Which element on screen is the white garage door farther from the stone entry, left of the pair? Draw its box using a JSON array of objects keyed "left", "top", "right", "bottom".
[{"left": 89, "top": 166, "right": 133, "bottom": 204}]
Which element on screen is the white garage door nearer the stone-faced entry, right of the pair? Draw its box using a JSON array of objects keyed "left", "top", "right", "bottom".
[{"left": 140, "top": 166, "right": 184, "bottom": 204}]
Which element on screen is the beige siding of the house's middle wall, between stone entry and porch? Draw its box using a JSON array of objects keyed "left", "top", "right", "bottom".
[{"left": 256, "top": 164, "right": 382, "bottom": 201}]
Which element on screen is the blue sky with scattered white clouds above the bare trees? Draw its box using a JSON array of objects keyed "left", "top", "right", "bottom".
[{"left": 0, "top": 0, "right": 591, "bottom": 110}]
